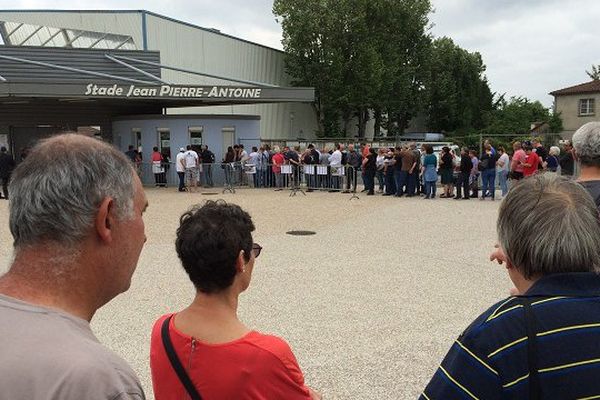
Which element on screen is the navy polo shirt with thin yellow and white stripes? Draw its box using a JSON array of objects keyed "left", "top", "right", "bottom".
[{"left": 420, "top": 273, "right": 600, "bottom": 400}]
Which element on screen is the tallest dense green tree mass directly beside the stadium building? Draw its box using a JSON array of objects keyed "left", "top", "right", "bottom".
[{"left": 273, "top": 0, "right": 431, "bottom": 137}]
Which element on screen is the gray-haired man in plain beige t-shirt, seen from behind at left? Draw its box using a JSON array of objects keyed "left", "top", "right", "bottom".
[{"left": 0, "top": 134, "right": 147, "bottom": 400}]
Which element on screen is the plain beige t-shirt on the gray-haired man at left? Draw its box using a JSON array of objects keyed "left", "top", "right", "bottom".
[{"left": 0, "top": 295, "right": 145, "bottom": 400}]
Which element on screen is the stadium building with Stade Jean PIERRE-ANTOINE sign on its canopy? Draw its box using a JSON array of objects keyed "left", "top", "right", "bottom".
[{"left": 0, "top": 10, "right": 317, "bottom": 159}]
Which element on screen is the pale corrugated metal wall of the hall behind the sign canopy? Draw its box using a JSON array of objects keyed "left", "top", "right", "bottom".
[{"left": 0, "top": 11, "right": 316, "bottom": 139}]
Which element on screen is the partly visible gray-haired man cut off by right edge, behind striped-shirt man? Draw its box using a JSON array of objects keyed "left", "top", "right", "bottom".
[{"left": 572, "top": 122, "right": 600, "bottom": 209}]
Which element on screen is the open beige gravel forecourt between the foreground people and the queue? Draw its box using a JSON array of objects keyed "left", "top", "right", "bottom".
[{"left": 0, "top": 188, "right": 511, "bottom": 399}]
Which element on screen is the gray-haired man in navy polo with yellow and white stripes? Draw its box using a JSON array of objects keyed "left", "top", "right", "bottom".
[{"left": 421, "top": 173, "right": 600, "bottom": 400}]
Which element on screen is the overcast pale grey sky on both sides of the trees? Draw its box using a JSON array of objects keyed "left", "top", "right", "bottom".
[{"left": 0, "top": 0, "right": 600, "bottom": 106}]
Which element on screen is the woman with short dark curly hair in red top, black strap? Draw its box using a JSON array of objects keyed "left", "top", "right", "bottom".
[{"left": 150, "top": 201, "right": 320, "bottom": 400}]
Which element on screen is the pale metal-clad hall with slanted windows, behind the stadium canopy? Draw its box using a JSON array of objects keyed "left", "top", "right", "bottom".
[{"left": 0, "top": 10, "right": 317, "bottom": 143}]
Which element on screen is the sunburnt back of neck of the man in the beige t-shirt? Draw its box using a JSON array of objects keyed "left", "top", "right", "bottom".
[{"left": 0, "top": 249, "right": 100, "bottom": 322}]
